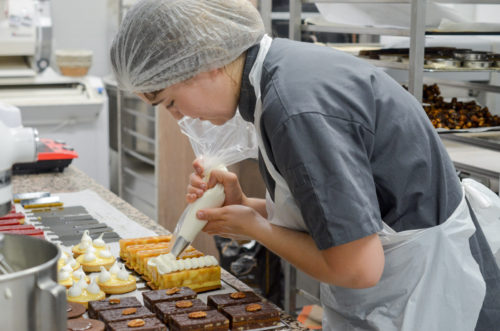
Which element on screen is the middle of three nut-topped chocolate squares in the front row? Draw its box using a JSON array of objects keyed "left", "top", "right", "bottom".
[{"left": 170, "top": 310, "right": 229, "bottom": 331}]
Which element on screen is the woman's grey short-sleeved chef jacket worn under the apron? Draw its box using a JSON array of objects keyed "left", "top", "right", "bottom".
[{"left": 239, "top": 39, "right": 500, "bottom": 330}]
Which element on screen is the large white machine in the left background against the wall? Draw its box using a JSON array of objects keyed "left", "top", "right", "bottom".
[{"left": 0, "top": 0, "right": 109, "bottom": 188}]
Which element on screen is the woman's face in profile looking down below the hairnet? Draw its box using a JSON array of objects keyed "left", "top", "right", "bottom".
[{"left": 137, "top": 69, "right": 239, "bottom": 125}]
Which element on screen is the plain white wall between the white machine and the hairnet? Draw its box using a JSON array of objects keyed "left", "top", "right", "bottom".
[{"left": 50, "top": 0, "right": 118, "bottom": 77}]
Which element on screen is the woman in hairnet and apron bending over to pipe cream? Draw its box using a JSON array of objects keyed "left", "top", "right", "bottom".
[{"left": 111, "top": 0, "right": 500, "bottom": 330}]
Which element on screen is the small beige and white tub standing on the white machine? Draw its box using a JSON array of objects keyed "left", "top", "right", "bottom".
[{"left": 55, "top": 49, "right": 92, "bottom": 77}]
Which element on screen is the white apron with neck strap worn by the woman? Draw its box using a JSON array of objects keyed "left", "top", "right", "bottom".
[{"left": 249, "top": 35, "right": 486, "bottom": 331}]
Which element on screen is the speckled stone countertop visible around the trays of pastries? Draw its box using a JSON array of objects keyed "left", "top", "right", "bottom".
[{"left": 12, "top": 166, "right": 308, "bottom": 330}]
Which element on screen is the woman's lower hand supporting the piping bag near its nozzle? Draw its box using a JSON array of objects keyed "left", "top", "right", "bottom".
[{"left": 196, "top": 205, "right": 267, "bottom": 239}]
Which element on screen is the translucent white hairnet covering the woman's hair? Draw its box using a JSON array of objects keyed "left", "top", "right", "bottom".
[{"left": 110, "top": 0, "right": 264, "bottom": 93}]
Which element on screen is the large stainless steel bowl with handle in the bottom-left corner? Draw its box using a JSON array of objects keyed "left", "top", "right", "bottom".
[{"left": 0, "top": 234, "right": 67, "bottom": 331}]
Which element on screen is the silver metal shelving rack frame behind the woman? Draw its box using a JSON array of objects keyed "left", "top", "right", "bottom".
[{"left": 286, "top": 0, "right": 500, "bottom": 314}]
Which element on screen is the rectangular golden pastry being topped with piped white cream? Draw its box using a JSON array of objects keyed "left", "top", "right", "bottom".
[{"left": 148, "top": 254, "right": 221, "bottom": 292}]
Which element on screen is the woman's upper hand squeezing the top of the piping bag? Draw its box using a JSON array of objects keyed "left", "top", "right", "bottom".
[{"left": 186, "top": 159, "right": 246, "bottom": 206}]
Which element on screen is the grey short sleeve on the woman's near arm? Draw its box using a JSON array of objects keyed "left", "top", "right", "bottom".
[{"left": 269, "top": 112, "right": 382, "bottom": 249}]
